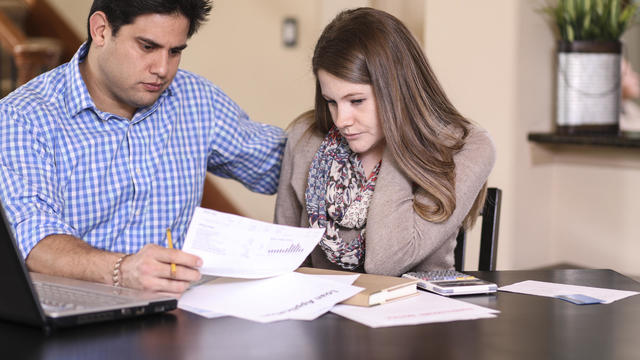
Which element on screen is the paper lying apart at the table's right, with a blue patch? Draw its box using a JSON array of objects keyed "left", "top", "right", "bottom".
[{"left": 498, "top": 280, "right": 640, "bottom": 304}]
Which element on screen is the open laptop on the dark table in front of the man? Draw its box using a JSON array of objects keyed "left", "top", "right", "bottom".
[{"left": 0, "top": 204, "right": 178, "bottom": 330}]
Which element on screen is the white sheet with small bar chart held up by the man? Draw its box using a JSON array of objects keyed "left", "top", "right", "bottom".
[{"left": 182, "top": 207, "right": 324, "bottom": 279}]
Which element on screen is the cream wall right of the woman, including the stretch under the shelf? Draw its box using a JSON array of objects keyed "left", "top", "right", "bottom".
[{"left": 425, "top": 0, "right": 640, "bottom": 276}]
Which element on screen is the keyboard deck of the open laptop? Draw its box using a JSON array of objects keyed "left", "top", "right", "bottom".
[{"left": 33, "top": 281, "right": 131, "bottom": 311}]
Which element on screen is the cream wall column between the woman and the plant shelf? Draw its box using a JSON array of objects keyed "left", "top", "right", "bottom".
[{"left": 425, "top": 0, "right": 557, "bottom": 269}]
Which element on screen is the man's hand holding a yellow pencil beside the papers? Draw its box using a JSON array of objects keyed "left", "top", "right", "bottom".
[{"left": 120, "top": 244, "right": 202, "bottom": 296}]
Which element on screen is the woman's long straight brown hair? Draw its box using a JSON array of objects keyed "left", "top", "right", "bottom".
[{"left": 312, "top": 8, "right": 485, "bottom": 228}]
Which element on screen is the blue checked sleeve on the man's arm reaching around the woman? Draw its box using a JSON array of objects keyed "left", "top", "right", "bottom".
[{"left": 207, "top": 88, "right": 286, "bottom": 194}]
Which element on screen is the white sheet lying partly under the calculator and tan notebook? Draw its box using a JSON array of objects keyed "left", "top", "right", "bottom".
[{"left": 331, "top": 291, "right": 499, "bottom": 328}]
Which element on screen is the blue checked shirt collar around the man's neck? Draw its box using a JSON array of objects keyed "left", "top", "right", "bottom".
[{"left": 65, "top": 42, "right": 173, "bottom": 120}]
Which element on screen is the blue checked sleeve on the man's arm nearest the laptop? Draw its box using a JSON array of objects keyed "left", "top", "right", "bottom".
[{"left": 0, "top": 106, "right": 78, "bottom": 258}]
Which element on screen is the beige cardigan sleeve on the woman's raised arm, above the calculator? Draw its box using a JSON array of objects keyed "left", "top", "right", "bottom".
[{"left": 365, "top": 129, "right": 495, "bottom": 276}]
